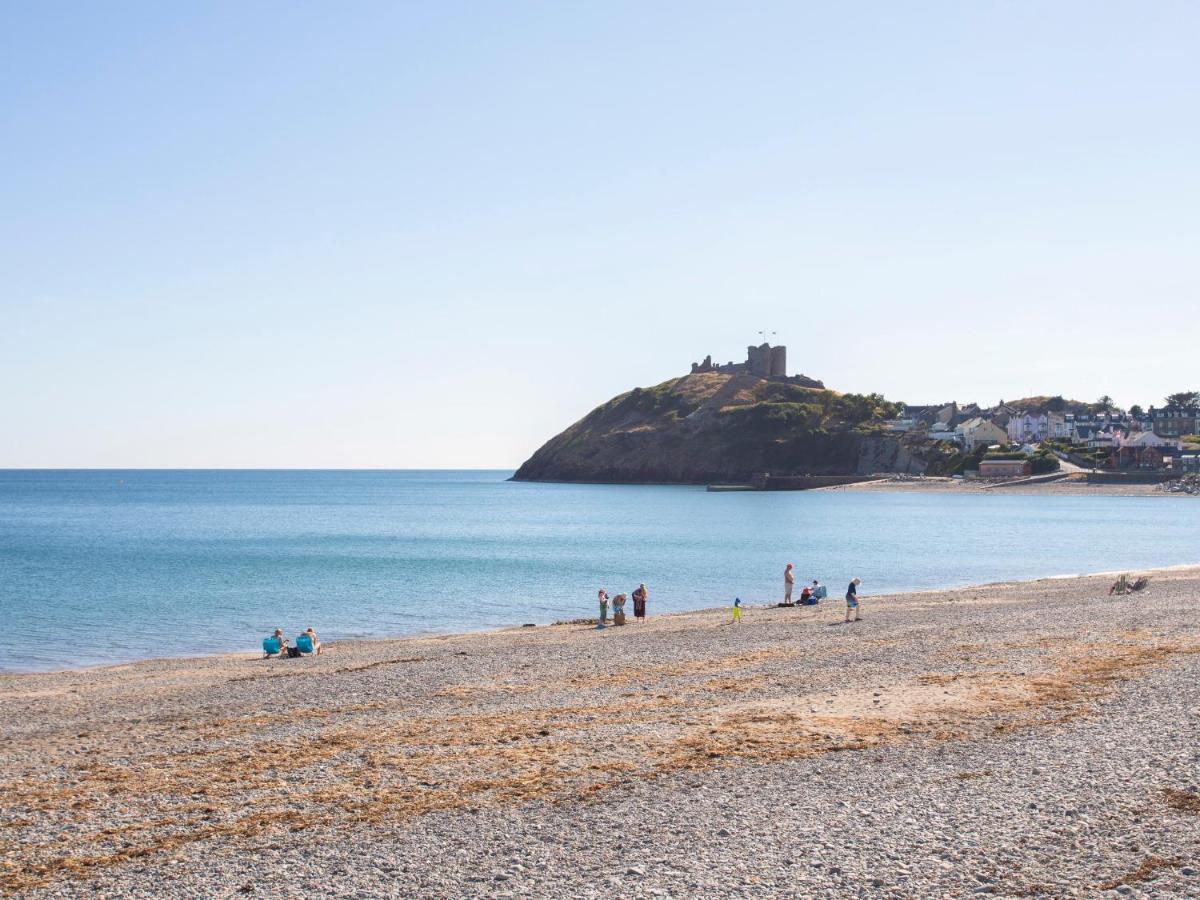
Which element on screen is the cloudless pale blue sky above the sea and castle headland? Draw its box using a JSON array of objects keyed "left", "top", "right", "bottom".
[{"left": 0, "top": 7, "right": 1200, "bottom": 467}]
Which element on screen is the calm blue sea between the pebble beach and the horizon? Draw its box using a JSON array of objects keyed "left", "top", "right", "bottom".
[{"left": 0, "top": 470, "right": 1200, "bottom": 671}]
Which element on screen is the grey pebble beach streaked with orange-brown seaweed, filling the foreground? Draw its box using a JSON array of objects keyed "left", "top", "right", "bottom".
[{"left": 0, "top": 568, "right": 1200, "bottom": 898}]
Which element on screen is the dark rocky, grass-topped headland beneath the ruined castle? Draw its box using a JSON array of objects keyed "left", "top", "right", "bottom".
[{"left": 514, "top": 372, "right": 945, "bottom": 484}]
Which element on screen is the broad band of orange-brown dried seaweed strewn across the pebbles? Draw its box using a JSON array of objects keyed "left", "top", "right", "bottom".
[{"left": 0, "top": 632, "right": 1198, "bottom": 893}]
